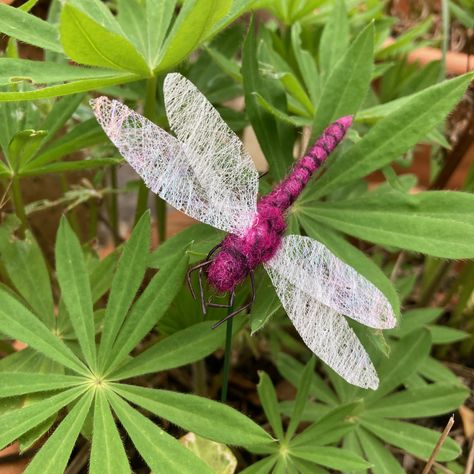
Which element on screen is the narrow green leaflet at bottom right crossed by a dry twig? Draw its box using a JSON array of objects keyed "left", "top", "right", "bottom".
[{"left": 360, "top": 417, "right": 461, "bottom": 462}]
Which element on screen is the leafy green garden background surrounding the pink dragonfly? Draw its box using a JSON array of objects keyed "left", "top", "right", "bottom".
[{"left": 0, "top": 0, "right": 474, "bottom": 473}]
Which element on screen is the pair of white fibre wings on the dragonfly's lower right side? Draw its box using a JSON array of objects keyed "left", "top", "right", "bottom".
[{"left": 265, "top": 235, "right": 396, "bottom": 389}]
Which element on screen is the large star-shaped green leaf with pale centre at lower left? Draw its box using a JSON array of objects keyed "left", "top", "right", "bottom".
[{"left": 0, "top": 214, "right": 272, "bottom": 472}]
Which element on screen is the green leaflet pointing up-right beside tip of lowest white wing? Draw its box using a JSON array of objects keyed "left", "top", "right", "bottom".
[{"left": 365, "top": 329, "right": 431, "bottom": 409}]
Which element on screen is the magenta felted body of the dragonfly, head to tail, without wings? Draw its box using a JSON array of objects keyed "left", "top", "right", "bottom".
[{"left": 207, "top": 116, "right": 352, "bottom": 292}]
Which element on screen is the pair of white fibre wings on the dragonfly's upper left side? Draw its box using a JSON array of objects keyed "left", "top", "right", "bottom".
[{"left": 92, "top": 74, "right": 258, "bottom": 234}]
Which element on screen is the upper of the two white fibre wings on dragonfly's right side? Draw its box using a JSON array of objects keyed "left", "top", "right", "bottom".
[{"left": 269, "top": 235, "right": 397, "bottom": 329}]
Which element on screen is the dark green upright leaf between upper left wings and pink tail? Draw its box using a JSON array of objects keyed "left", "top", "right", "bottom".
[{"left": 242, "top": 21, "right": 294, "bottom": 180}]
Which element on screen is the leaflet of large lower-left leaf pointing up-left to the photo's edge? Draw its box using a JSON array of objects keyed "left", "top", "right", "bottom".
[{"left": 0, "top": 288, "right": 88, "bottom": 374}]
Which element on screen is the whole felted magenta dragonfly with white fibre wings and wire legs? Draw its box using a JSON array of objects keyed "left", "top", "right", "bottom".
[{"left": 91, "top": 73, "right": 396, "bottom": 389}]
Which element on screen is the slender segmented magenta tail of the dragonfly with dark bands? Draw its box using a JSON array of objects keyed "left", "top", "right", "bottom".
[{"left": 259, "top": 115, "right": 352, "bottom": 211}]
